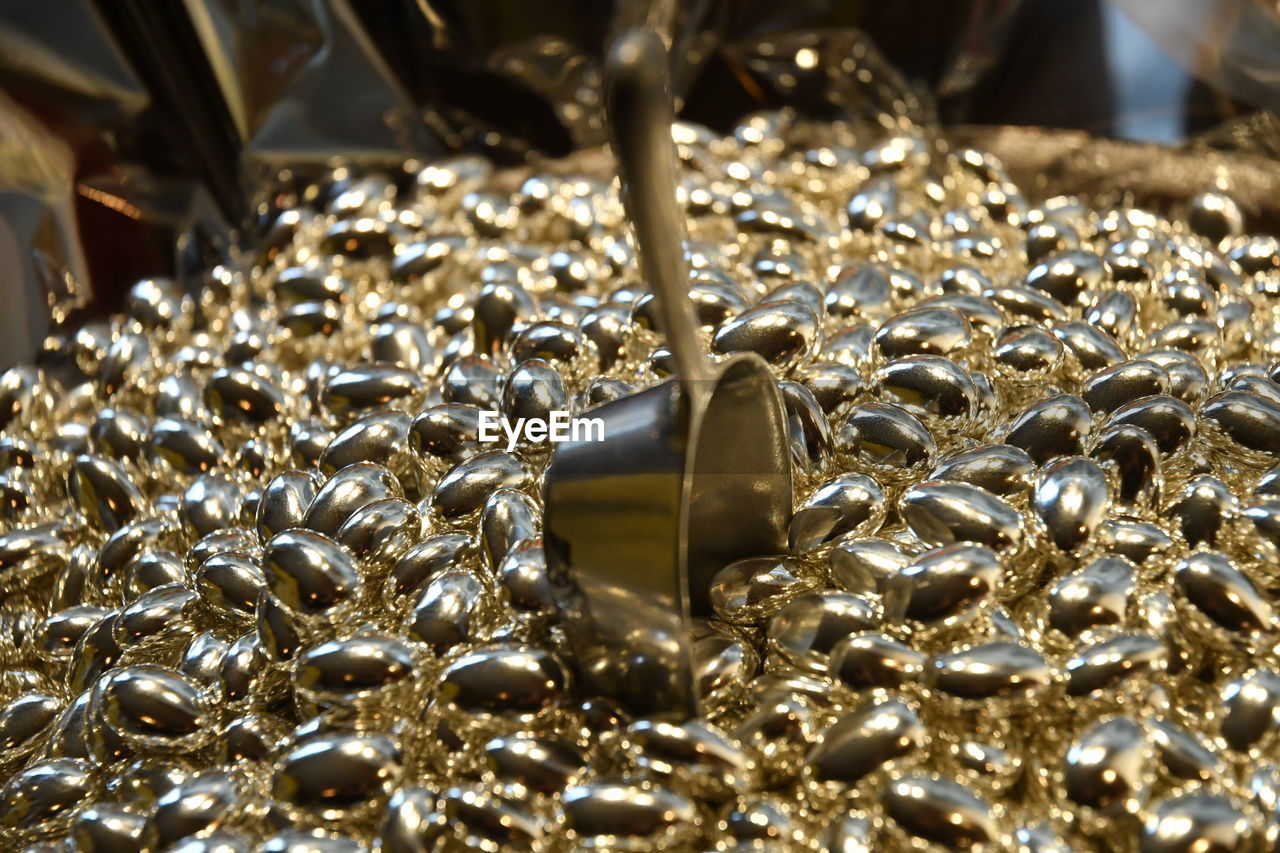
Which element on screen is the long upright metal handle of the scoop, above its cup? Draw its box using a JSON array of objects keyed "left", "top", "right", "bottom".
[{"left": 604, "top": 27, "right": 712, "bottom": 387}]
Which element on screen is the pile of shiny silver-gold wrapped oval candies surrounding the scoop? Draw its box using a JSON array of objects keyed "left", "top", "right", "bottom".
[{"left": 0, "top": 113, "right": 1280, "bottom": 853}]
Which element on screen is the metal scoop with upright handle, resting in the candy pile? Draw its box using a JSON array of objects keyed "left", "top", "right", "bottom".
[{"left": 544, "top": 29, "right": 791, "bottom": 715}]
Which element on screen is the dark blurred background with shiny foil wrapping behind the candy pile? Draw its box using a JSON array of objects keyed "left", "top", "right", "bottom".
[{"left": 0, "top": 0, "right": 1280, "bottom": 368}]
